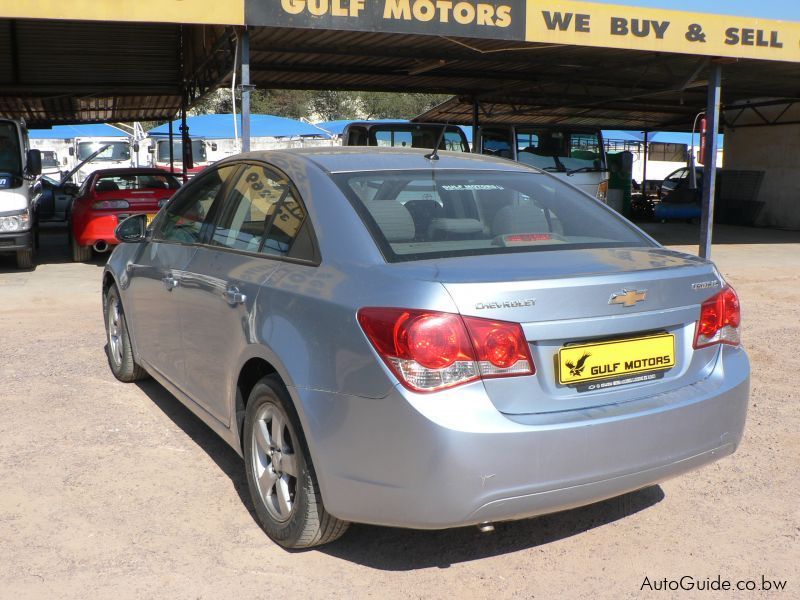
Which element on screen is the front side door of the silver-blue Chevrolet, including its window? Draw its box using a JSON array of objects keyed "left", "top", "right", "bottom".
[{"left": 125, "top": 166, "right": 235, "bottom": 389}]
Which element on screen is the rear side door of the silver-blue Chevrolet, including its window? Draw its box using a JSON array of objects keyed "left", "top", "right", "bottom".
[{"left": 182, "top": 163, "right": 318, "bottom": 424}]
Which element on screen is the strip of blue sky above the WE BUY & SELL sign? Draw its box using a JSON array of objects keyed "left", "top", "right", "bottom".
[{"left": 590, "top": 0, "right": 800, "bottom": 21}]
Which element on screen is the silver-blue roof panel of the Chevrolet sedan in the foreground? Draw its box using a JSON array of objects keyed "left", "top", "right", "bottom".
[{"left": 221, "top": 146, "right": 541, "bottom": 173}]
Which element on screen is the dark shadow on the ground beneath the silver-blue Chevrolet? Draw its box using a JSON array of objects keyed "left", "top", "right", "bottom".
[{"left": 137, "top": 379, "right": 664, "bottom": 571}]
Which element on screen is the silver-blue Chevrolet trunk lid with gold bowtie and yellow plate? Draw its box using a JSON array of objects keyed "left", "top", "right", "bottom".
[{"left": 418, "top": 248, "right": 723, "bottom": 414}]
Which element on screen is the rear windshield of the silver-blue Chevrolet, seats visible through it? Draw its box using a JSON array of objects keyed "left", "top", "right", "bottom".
[{"left": 333, "top": 170, "right": 653, "bottom": 262}]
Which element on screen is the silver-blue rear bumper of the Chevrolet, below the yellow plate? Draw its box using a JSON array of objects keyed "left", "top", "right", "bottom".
[{"left": 291, "top": 347, "right": 749, "bottom": 529}]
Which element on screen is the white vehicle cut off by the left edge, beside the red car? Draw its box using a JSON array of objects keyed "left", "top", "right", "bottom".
[{"left": 0, "top": 119, "right": 42, "bottom": 269}]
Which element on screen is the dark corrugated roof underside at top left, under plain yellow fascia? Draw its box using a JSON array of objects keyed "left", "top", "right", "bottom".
[{"left": 0, "top": 19, "right": 230, "bottom": 127}]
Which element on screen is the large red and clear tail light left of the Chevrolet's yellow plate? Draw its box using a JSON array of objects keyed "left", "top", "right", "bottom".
[{"left": 358, "top": 308, "right": 535, "bottom": 392}]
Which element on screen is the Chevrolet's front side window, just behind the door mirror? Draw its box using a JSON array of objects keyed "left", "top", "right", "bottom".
[{"left": 157, "top": 166, "right": 236, "bottom": 244}]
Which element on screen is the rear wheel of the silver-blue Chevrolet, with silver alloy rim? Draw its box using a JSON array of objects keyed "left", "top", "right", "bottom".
[{"left": 243, "top": 375, "right": 350, "bottom": 548}]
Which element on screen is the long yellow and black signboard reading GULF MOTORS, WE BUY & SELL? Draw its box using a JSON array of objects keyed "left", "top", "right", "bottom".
[{"left": 0, "top": 0, "right": 800, "bottom": 62}]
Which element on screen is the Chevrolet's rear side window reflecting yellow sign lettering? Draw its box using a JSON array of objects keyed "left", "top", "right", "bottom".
[{"left": 211, "top": 165, "right": 306, "bottom": 256}]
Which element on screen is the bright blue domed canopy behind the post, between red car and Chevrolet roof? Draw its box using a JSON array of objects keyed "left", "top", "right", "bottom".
[{"left": 147, "top": 113, "right": 331, "bottom": 140}]
